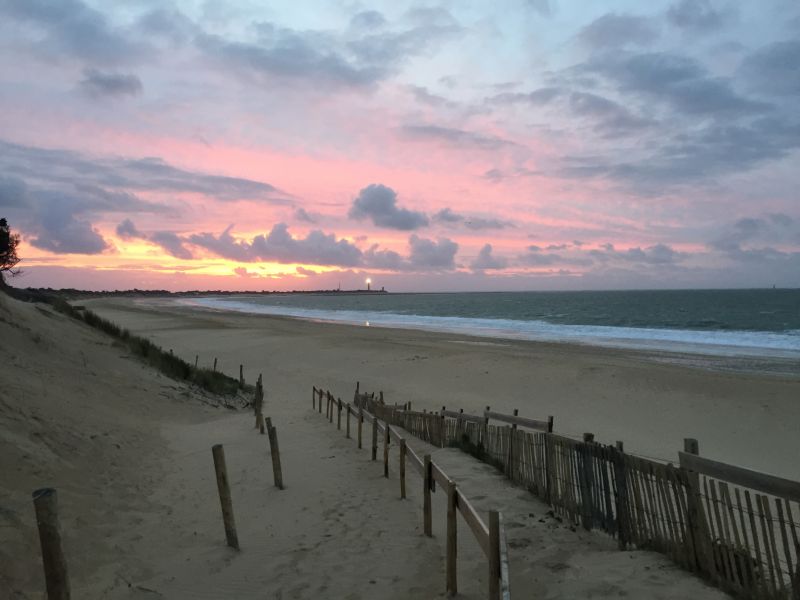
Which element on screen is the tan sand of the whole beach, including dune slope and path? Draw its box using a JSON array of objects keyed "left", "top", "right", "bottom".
[{"left": 0, "top": 298, "right": 800, "bottom": 599}]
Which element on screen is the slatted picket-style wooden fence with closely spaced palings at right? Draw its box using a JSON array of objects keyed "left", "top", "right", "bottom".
[{"left": 346, "top": 390, "right": 800, "bottom": 600}]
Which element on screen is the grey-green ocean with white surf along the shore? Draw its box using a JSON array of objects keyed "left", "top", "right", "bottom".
[{"left": 183, "top": 289, "right": 800, "bottom": 366}]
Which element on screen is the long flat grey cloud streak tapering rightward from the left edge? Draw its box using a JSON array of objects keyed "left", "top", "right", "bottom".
[{"left": 0, "top": 140, "right": 287, "bottom": 207}]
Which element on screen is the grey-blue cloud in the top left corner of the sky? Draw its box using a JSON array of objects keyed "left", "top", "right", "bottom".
[{"left": 0, "top": 0, "right": 149, "bottom": 64}]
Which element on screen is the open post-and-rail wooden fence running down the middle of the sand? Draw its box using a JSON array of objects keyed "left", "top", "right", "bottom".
[{"left": 311, "top": 386, "right": 511, "bottom": 600}]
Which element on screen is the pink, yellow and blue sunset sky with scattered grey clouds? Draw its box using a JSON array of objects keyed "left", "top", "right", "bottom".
[{"left": 0, "top": 0, "right": 800, "bottom": 291}]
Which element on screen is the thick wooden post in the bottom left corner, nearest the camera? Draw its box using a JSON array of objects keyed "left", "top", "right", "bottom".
[{"left": 32, "top": 488, "right": 70, "bottom": 600}]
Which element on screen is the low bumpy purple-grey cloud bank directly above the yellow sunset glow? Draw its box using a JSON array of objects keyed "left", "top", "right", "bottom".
[{"left": 187, "top": 223, "right": 361, "bottom": 267}]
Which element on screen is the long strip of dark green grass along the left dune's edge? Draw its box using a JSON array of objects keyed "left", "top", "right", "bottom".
[{"left": 3, "top": 288, "right": 248, "bottom": 396}]
